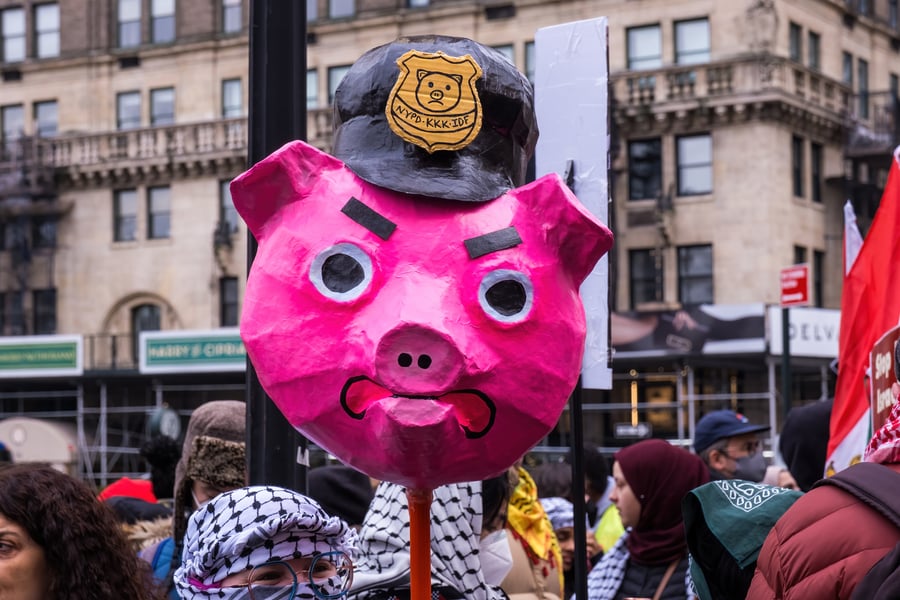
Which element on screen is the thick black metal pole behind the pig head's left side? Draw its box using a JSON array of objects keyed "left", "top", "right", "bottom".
[{"left": 247, "top": 0, "right": 307, "bottom": 493}]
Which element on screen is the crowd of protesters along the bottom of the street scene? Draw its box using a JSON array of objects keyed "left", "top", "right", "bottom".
[{"left": 0, "top": 402, "right": 900, "bottom": 600}]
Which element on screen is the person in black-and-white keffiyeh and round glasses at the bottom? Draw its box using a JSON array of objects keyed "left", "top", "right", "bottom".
[{"left": 175, "top": 485, "right": 357, "bottom": 600}]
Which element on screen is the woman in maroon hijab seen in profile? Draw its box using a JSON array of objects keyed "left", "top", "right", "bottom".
[{"left": 588, "top": 440, "right": 709, "bottom": 600}]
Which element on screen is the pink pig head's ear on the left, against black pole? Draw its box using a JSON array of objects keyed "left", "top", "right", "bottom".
[{"left": 231, "top": 141, "right": 344, "bottom": 239}]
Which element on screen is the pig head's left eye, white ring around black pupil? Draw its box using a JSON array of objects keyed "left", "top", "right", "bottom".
[{"left": 309, "top": 244, "right": 372, "bottom": 302}]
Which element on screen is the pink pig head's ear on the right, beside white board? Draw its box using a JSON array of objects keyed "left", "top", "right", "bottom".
[{"left": 515, "top": 173, "right": 613, "bottom": 285}]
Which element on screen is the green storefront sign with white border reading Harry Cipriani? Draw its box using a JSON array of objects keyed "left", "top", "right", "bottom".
[{"left": 141, "top": 330, "right": 247, "bottom": 373}]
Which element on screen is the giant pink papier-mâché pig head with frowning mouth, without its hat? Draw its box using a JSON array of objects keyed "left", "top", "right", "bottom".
[{"left": 231, "top": 35, "right": 612, "bottom": 489}]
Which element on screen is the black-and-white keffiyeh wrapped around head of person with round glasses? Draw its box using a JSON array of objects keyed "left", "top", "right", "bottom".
[{"left": 175, "top": 486, "right": 357, "bottom": 600}]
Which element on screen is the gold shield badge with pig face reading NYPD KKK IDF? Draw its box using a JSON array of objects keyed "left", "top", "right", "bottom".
[{"left": 384, "top": 50, "right": 482, "bottom": 154}]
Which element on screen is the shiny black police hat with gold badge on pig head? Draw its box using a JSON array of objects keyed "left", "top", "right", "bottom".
[{"left": 333, "top": 36, "right": 538, "bottom": 202}]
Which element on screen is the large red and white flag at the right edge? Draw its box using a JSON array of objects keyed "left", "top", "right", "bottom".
[{"left": 826, "top": 148, "right": 900, "bottom": 472}]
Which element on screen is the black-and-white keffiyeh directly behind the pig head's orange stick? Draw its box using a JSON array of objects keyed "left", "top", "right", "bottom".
[{"left": 350, "top": 482, "right": 507, "bottom": 600}]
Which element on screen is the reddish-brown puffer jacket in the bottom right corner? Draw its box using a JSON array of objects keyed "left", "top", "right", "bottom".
[{"left": 747, "top": 486, "right": 900, "bottom": 600}]
